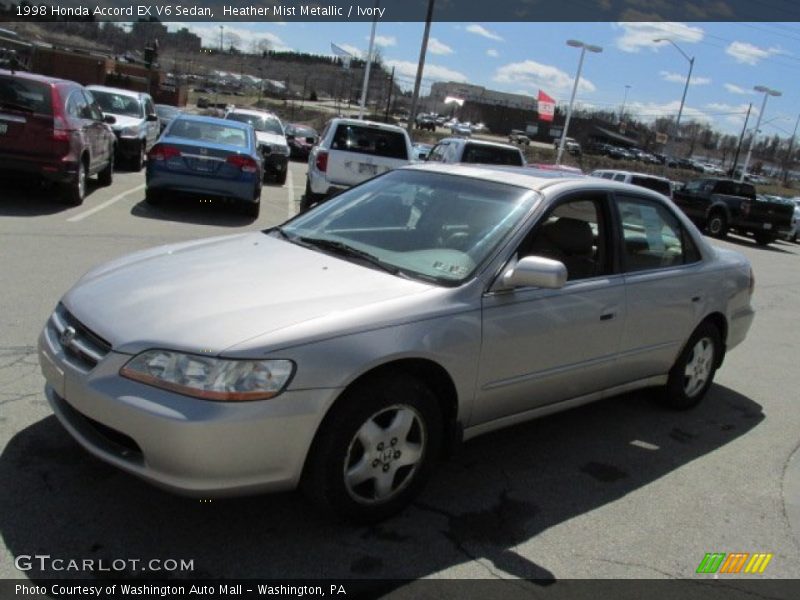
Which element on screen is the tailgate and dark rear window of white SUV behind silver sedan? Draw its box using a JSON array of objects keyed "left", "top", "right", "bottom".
[{"left": 327, "top": 124, "right": 409, "bottom": 185}]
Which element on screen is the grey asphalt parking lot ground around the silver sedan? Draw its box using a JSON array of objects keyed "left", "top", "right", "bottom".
[{"left": 0, "top": 163, "right": 800, "bottom": 581}]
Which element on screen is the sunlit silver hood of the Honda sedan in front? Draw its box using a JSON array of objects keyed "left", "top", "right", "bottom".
[{"left": 62, "top": 232, "right": 441, "bottom": 354}]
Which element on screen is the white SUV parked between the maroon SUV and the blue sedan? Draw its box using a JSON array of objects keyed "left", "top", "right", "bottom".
[{"left": 86, "top": 85, "right": 161, "bottom": 171}]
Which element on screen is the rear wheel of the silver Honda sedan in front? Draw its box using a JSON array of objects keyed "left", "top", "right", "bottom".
[{"left": 661, "top": 322, "right": 722, "bottom": 410}]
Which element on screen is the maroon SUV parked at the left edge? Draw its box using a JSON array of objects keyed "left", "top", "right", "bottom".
[{"left": 0, "top": 70, "right": 116, "bottom": 206}]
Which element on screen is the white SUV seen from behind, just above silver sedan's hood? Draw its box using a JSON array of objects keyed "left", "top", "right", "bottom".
[{"left": 300, "top": 118, "right": 413, "bottom": 211}]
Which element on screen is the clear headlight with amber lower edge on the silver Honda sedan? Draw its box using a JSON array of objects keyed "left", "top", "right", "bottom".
[{"left": 119, "top": 350, "right": 294, "bottom": 402}]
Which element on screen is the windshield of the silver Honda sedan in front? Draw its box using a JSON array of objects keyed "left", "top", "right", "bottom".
[{"left": 276, "top": 169, "right": 539, "bottom": 285}]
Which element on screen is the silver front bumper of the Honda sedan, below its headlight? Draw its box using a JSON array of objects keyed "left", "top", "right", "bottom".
[{"left": 39, "top": 326, "right": 339, "bottom": 497}]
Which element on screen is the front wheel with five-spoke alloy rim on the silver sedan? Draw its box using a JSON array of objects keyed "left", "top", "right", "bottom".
[{"left": 302, "top": 374, "right": 442, "bottom": 523}]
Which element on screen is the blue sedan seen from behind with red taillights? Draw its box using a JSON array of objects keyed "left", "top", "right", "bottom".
[{"left": 146, "top": 115, "right": 263, "bottom": 217}]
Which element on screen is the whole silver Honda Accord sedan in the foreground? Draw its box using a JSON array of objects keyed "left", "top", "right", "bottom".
[{"left": 39, "top": 165, "right": 754, "bottom": 521}]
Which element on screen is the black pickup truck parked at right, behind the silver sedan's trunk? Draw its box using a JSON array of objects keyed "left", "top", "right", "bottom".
[{"left": 673, "top": 177, "right": 794, "bottom": 246}]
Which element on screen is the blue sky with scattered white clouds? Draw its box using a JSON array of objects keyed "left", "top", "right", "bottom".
[{"left": 169, "top": 22, "right": 800, "bottom": 137}]
